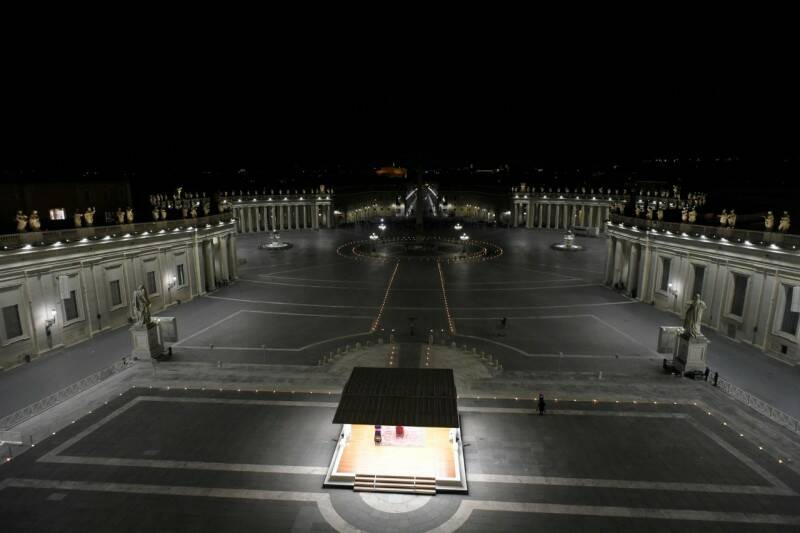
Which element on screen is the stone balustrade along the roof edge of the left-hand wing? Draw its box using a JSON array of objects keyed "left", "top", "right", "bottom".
[{"left": 0, "top": 213, "right": 233, "bottom": 249}]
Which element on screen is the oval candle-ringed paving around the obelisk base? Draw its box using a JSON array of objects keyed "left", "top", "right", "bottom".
[{"left": 337, "top": 235, "right": 503, "bottom": 263}]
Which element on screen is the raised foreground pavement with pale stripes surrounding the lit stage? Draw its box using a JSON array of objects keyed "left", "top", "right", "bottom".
[{"left": 0, "top": 388, "right": 800, "bottom": 532}]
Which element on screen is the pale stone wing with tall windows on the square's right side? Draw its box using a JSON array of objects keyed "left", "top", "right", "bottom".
[{"left": 605, "top": 216, "right": 800, "bottom": 362}]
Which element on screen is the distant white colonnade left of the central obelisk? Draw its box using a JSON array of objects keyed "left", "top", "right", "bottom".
[{"left": 233, "top": 202, "right": 333, "bottom": 233}]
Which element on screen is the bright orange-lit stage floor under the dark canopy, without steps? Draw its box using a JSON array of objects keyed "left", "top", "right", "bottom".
[{"left": 337, "top": 424, "right": 456, "bottom": 479}]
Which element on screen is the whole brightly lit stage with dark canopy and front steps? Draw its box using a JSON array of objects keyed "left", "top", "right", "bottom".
[{"left": 325, "top": 367, "right": 467, "bottom": 494}]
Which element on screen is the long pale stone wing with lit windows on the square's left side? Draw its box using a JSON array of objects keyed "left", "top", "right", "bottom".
[{"left": 0, "top": 216, "right": 238, "bottom": 367}]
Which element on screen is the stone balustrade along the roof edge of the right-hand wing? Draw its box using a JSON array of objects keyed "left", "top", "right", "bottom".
[{"left": 611, "top": 214, "right": 800, "bottom": 250}]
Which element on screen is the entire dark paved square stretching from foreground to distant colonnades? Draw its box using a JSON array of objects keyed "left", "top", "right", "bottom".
[{"left": 0, "top": 228, "right": 800, "bottom": 532}]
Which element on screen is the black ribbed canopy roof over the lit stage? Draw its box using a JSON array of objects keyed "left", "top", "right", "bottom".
[{"left": 333, "top": 367, "right": 458, "bottom": 428}]
